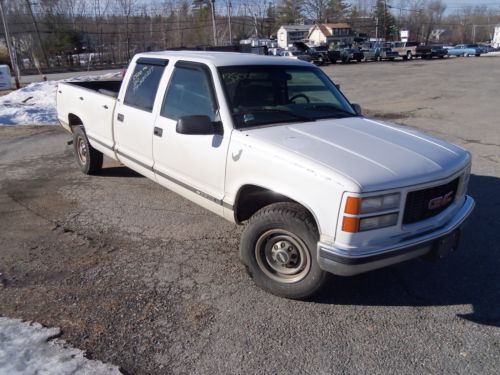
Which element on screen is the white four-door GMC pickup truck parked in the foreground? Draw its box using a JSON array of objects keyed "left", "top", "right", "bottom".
[{"left": 57, "top": 51, "right": 474, "bottom": 299}]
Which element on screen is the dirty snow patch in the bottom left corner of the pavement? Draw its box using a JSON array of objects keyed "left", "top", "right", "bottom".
[{"left": 0, "top": 317, "right": 121, "bottom": 375}]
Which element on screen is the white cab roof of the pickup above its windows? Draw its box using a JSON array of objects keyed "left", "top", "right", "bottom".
[{"left": 136, "top": 51, "right": 312, "bottom": 67}]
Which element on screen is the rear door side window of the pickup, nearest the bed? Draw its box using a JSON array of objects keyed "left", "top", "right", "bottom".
[{"left": 123, "top": 60, "right": 165, "bottom": 112}]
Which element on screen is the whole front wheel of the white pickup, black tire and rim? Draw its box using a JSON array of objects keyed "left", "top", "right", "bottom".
[{"left": 240, "top": 203, "right": 327, "bottom": 299}]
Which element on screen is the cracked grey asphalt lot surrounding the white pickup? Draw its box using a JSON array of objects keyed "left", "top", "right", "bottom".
[{"left": 0, "top": 57, "right": 500, "bottom": 374}]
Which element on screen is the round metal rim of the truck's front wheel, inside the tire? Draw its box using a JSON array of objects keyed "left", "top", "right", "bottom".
[{"left": 255, "top": 229, "right": 311, "bottom": 284}]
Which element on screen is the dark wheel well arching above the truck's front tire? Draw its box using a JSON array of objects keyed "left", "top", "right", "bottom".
[{"left": 234, "top": 185, "right": 318, "bottom": 227}]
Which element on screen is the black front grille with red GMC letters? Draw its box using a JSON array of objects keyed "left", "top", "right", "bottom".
[{"left": 403, "top": 178, "right": 459, "bottom": 224}]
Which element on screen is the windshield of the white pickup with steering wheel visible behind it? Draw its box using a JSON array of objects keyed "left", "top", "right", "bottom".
[{"left": 219, "top": 65, "right": 357, "bottom": 128}]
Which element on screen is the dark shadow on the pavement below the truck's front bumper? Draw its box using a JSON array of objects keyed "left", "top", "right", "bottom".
[{"left": 315, "top": 175, "right": 500, "bottom": 327}]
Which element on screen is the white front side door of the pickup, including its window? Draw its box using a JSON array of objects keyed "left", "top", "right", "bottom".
[{"left": 153, "top": 61, "right": 229, "bottom": 214}]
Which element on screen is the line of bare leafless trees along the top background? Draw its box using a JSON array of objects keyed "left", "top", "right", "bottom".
[{"left": 0, "top": 0, "right": 500, "bottom": 70}]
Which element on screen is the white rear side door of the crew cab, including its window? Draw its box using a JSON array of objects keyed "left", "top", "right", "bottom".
[{"left": 113, "top": 58, "right": 168, "bottom": 178}]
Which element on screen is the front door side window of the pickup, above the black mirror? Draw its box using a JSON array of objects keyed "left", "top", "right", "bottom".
[{"left": 160, "top": 65, "right": 216, "bottom": 121}]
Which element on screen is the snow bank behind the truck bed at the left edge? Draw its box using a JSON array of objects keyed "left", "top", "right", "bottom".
[{"left": 0, "top": 73, "right": 120, "bottom": 125}]
